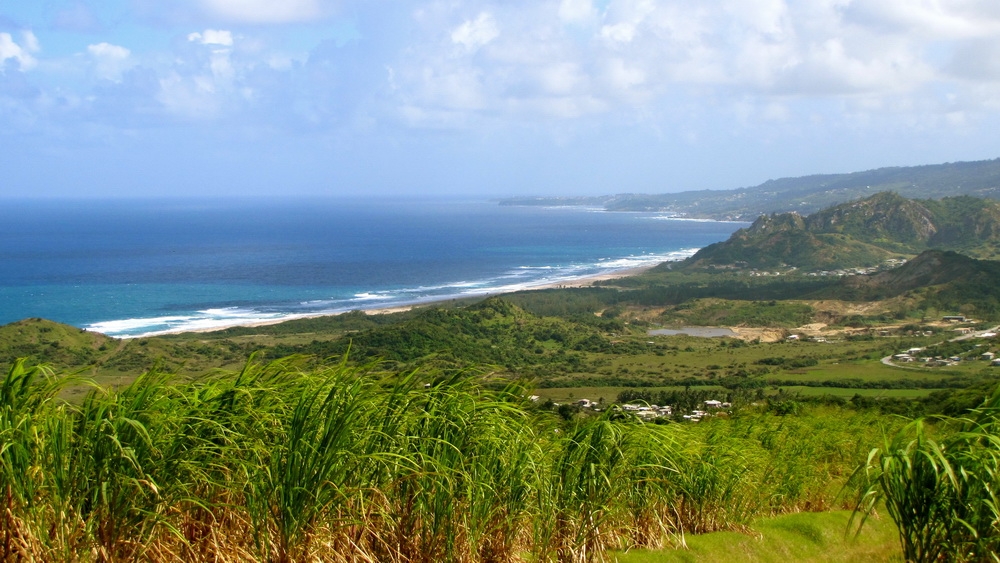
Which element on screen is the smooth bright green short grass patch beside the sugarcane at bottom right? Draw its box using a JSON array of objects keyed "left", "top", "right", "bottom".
[{"left": 614, "top": 510, "right": 903, "bottom": 563}]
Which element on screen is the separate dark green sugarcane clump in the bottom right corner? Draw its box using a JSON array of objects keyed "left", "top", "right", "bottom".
[{"left": 855, "top": 388, "right": 1000, "bottom": 563}]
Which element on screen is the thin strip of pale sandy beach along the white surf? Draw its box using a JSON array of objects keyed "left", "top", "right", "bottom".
[{"left": 137, "top": 264, "right": 659, "bottom": 340}]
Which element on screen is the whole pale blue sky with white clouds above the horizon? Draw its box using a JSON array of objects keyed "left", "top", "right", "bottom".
[{"left": 0, "top": 0, "right": 1000, "bottom": 197}]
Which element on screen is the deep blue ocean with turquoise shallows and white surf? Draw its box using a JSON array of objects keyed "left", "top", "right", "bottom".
[{"left": 0, "top": 199, "right": 745, "bottom": 336}]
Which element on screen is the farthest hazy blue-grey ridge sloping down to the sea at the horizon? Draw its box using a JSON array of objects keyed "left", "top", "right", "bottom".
[{"left": 500, "top": 159, "right": 1000, "bottom": 221}]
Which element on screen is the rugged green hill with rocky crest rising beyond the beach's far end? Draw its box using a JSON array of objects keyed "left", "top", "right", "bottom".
[{"left": 685, "top": 192, "right": 1000, "bottom": 270}]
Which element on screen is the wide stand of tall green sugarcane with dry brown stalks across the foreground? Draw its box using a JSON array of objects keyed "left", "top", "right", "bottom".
[{"left": 0, "top": 357, "right": 892, "bottom": 563}]
